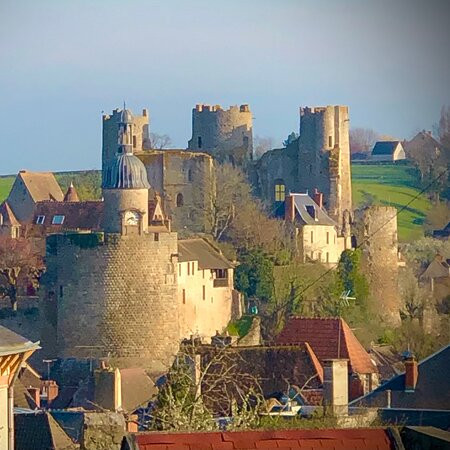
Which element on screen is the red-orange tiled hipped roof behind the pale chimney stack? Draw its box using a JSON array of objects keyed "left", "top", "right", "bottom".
[{"left": 275, "top": 317, "right": 377, "bottom": 374}]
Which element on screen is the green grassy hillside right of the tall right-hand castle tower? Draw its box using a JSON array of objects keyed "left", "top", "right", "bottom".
[{"left": 352, "top": 164, "right": 431, "bottom": 242}]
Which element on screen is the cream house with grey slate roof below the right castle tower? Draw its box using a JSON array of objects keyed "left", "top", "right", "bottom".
[{"left": 284, "top": 191, "right": 351, "bottom": 264}]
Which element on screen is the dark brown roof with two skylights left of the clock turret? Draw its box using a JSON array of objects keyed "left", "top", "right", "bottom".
[{"left": 32, "top": 201, "right": 104, "bottom": 232}]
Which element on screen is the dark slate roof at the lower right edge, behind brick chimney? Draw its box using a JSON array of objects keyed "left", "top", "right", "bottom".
[{"left": 350, "top": 345, "right": 450, "bottom": 410}]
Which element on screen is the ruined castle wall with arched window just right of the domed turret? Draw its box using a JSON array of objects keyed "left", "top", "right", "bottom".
[{"left": 136, "top": 150, "right": 215, "bottom": 231}]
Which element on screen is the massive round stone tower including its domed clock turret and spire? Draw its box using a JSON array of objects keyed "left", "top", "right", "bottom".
[{"left": 42, "top": 110, "right": 180, "bottom": 372}]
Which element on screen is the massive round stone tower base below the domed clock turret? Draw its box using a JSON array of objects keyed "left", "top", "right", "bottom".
[{"left": 43, "top": 233, "right": 179, "bottom": 370}]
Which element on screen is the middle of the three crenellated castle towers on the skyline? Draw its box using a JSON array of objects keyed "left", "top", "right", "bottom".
[{"left": 188, "top": 104, "right": 253, "bottom": 165}]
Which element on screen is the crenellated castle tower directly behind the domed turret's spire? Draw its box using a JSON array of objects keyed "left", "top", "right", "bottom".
[{"left": 102, "top": 106, "right": 150, "bottom": 182}]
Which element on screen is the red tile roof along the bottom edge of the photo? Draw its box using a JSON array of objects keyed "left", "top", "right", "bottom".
[{"left": 129, "top": 428, "right": 394, "bottom": 450}]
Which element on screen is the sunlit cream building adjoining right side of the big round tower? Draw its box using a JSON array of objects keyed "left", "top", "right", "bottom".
[{"left": 177, "top": 239, "right": 240, "bottom": 339}]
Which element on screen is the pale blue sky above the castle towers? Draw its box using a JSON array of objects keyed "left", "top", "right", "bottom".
[{"left": 0, "top": 0, "right": 450, "bottom": 174}]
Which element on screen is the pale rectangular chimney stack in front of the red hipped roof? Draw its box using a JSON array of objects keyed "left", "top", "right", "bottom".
[{"left": 323, "top": 359, "right": 348, "bottom": 417}]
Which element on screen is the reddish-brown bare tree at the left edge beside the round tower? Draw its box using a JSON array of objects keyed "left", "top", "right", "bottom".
[{"left": 0, "top": 236, "right": 44, "bottom": 310}]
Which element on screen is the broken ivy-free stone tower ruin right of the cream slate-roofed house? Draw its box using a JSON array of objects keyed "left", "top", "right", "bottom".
[{"left": 356, "top": 206, "right": 401, "bottom": 326}]
